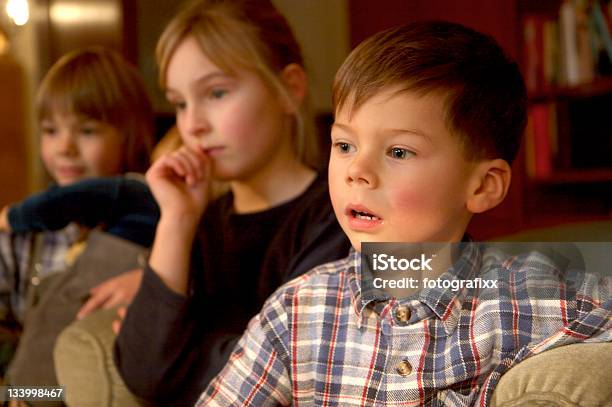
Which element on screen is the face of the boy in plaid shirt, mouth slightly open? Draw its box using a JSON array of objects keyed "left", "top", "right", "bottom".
[{"left": 329, "top": 89, "right": 476, "bottom": 250}]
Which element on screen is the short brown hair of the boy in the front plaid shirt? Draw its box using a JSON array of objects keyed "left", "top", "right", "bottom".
[{"left": 332, "top": 21, "right": 527, "bottom": 163}]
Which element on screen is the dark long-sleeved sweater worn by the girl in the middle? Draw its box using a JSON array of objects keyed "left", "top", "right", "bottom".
[{"left": 115, "top": 175, "right": 350, "bottom": 406}]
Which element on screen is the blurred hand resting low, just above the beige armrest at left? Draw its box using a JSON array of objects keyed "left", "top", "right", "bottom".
[{"left": 77, "top": 270, "right": 143, "bottom": 319}]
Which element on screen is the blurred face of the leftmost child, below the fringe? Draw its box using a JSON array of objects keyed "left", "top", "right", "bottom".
[{"left": 40, "top": 113, "right": 122, "bottom": 185}]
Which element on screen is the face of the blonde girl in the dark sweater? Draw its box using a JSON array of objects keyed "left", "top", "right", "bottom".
[{"left": 166, "top": 37, "right": 292, "bottom": 180}]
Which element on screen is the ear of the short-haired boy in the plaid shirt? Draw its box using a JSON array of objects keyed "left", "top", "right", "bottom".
[{"left": 467, "top": 158, "right": 512, "bottom": 213}]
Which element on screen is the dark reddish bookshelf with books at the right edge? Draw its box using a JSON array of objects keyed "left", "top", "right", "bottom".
[{"left": 517, "top": 0, "right": 612, "bottom": 231}]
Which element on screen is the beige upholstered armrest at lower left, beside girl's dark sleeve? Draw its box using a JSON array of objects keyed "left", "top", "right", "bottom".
[{"left": 53, "top": 309, "right": 141, "bottom": 407}]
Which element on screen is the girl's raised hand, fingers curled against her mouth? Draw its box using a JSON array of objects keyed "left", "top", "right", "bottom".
[{"left": 146, "top": 146, "right": 210, "bottom": 222}]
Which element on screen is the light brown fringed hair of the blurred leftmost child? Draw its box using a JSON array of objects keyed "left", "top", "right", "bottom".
[{"left": 36, "top": 47, "right": 154, "bottom": 172}]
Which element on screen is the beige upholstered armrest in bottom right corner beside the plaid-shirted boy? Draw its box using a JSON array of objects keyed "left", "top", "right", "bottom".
[{"left": 491, "top": 343, "right": 612, "bottom": 407}]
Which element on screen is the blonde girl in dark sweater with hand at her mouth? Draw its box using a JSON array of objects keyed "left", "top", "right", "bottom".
[{"left": 115, "top": 0, "right": 350, "bottom": 405}]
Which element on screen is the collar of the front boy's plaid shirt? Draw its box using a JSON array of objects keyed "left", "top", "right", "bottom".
[{"left": 348, "top": 241, "right": 482, "bottom": 334}]
